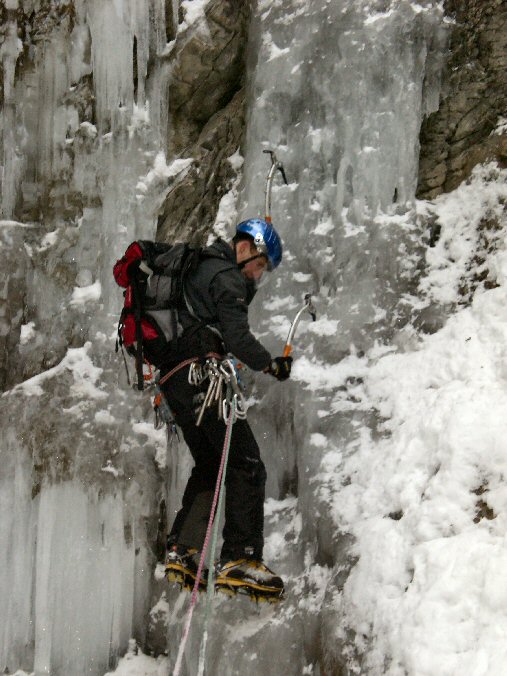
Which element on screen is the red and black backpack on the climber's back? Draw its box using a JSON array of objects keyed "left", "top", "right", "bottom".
[{"left": 113, "top": 240, "right": 201, "bottom": 390}]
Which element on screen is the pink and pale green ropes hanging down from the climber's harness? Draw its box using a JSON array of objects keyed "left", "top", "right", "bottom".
[{"left": 173, "top": 398, "right": 236, "bottom": 676}]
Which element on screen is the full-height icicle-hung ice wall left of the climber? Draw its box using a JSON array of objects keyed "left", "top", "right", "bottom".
[{"left": 0, "top": 0, "right": 181, "bottom": 676}]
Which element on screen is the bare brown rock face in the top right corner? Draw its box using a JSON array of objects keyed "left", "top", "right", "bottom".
[{"left": 418, "top": 0, "right": 507, "bottom": 199}]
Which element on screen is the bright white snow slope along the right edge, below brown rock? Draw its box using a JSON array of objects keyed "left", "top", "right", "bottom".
[{"left": 314, "top": 166, "right": 507, "bottom": 676}]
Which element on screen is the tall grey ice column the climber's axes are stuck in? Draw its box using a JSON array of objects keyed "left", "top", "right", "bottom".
[{"left": 164, "top": 0, "right": 446, "bottom": 675}]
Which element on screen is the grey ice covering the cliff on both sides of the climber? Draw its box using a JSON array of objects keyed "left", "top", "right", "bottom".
[{"left": 0, "top": 0, "right": 452, "bottom": 676}]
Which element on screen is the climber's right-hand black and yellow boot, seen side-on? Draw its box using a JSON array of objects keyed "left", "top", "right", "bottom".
[{"left": 215, "top": 559, "right": 284, "bottom": 601}]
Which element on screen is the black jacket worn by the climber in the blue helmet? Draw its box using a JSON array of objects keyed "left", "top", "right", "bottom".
[{"left": 180, "top": 239, "right": 271, "bottom": 371}]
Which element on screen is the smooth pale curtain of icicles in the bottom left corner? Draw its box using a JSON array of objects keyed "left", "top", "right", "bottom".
[{"left": 0, "top": 480, "right": 137, "bottom": 674}]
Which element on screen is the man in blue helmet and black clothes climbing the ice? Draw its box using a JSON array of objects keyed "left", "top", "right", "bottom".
[{"left": 165, "top": 219, "right": 292, "bottom": 595}]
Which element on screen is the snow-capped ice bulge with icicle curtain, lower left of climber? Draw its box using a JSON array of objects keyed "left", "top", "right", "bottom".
[{"left": 0, "top": 343, "right": 165, "bottom": 676}]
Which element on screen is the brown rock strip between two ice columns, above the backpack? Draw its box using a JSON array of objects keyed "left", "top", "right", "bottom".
[{"left": 158, "top": 0, "right": 249, "bottom": 241}]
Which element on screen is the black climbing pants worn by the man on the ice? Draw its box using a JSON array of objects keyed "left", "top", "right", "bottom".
[{"left": 163, "top": 367, "right": 266, "bottom": 560}]
